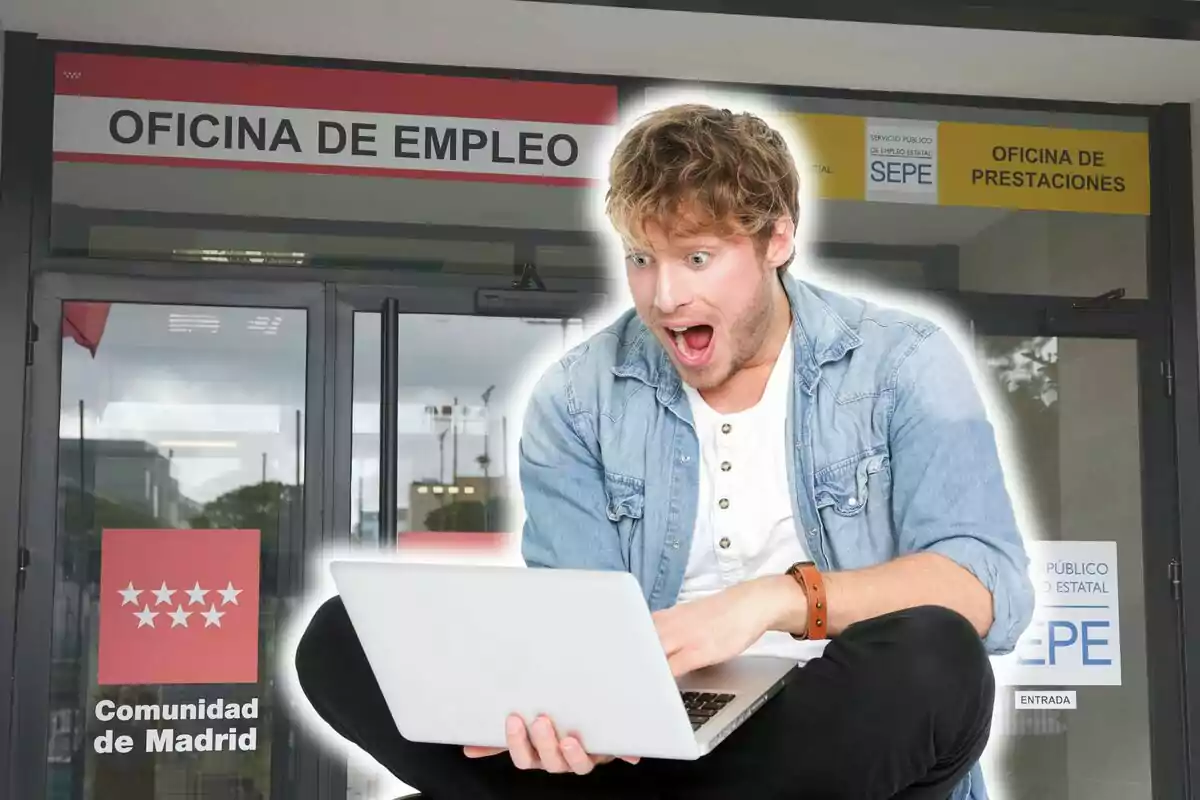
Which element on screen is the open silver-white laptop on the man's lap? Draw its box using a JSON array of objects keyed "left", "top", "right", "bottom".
[{"left": 330, "top": 560, "right": 796, "bottom": 759}]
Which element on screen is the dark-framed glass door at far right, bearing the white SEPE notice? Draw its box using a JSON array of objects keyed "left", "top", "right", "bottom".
[{"left": 945, "top": 296, "right": 1186, "bottom": 800}]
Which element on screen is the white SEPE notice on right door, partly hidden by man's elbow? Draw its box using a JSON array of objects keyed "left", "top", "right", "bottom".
[{"left": 1008, "top": 542, "right": 1121, "bottom": 686}]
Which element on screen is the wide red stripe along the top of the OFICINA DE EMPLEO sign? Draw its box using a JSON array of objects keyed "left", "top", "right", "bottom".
[{"left": 54, "top": 53, "right": 617, "bottom": 125}]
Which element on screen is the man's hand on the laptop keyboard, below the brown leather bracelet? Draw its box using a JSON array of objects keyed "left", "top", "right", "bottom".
[{"left": 654, "top": 576, "right": 803, "bottom": 678}]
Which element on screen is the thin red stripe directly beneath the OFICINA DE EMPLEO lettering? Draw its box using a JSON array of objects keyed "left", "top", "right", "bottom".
[{"left": 54, "top": 152, "right": 593, "bottom": 186}]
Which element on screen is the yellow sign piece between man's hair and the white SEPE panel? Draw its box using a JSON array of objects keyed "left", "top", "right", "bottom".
[{"left": 792, "top": 114, "right": 866, "bottom": 200}]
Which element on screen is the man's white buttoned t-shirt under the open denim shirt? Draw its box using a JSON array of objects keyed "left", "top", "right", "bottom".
[{"left": 678, "top": 336, "right": 827, "bottom": 662}]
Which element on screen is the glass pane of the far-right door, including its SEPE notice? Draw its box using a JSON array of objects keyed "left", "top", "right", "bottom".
[{"left": 977, "top": 336, "right": 1156, "bottom": 800}]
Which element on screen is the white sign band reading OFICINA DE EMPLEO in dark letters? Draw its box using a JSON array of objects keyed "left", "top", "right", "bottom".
[{"left": 54, "top": 95, "right": 605, "bottom": 180}]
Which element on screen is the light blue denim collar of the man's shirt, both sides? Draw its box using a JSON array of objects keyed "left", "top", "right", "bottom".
[{"left": 612, "top": 271, "right": 863, "bottom": 405}]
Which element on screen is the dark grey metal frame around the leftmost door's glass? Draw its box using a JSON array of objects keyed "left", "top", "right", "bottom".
[{"left": 13, "top": 272, "right": 328, "bottom": 798}]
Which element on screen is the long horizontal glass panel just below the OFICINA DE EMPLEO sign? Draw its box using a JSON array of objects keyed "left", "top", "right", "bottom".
[{"left": 50, "top": 161, "right": 598, "bottom": 277}]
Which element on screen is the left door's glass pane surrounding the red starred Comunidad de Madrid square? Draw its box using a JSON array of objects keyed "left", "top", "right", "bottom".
[{"left": 47, "top": 302, "right": 307, "bottom": 800}]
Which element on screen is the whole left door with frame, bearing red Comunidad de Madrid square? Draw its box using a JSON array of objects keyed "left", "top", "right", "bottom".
[{"left": 14, "top": 275, "right": 325, "bottom": 800}]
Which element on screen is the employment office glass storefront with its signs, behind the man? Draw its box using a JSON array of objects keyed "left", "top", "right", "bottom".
[{"left": 0, "top": 7, "right": 1200, "bottom": 800}]
